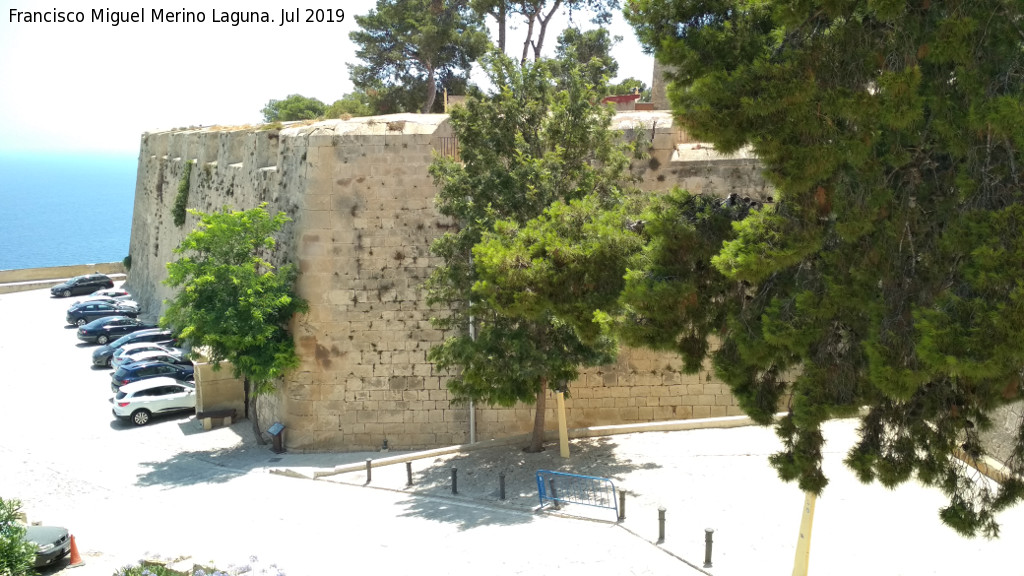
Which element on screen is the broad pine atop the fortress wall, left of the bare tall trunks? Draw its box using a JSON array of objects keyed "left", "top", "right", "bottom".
[{"left": 349, "top": 0, "right": 489, "bottom": 113}]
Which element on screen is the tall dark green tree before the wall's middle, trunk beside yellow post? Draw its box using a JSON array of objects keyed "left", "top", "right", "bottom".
[{"left": 427, "top": 54, "right": 629, "bottom": 451}]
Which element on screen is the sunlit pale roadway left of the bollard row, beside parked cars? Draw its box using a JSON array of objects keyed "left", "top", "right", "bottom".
[{"left": 0, "top": 291, "right": 696, "bottom": 576}]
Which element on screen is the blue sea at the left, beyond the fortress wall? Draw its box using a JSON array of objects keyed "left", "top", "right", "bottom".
[{"left": 0, "top": 152, "right": 138, "bottom": 270}]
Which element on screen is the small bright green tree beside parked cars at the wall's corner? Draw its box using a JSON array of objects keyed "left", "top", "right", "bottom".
[{"left": 160, "top": 203, "right": 308, "bottom": 444}]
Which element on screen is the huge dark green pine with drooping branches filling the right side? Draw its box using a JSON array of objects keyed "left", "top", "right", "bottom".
[{"left": 627, "top": 0, "right": 1024, "bottom": 536}]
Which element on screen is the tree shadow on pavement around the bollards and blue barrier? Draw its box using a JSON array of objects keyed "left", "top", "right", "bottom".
[{"left": 387, "top": 437, "right": 660, "bottom": 530}]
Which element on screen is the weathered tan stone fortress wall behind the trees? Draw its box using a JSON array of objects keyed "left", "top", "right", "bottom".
[{"left": 128, "top": 112, "right": 771, "bottom": 451}]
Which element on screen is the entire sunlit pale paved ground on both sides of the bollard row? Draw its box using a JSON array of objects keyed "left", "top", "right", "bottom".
[{"left": 0, "top": 284, "right": 1024, "bottom": 576}]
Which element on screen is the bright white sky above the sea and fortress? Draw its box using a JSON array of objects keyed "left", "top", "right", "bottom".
[{"left": 0, "top": 0, "right": 652, "bottom": 154}]
